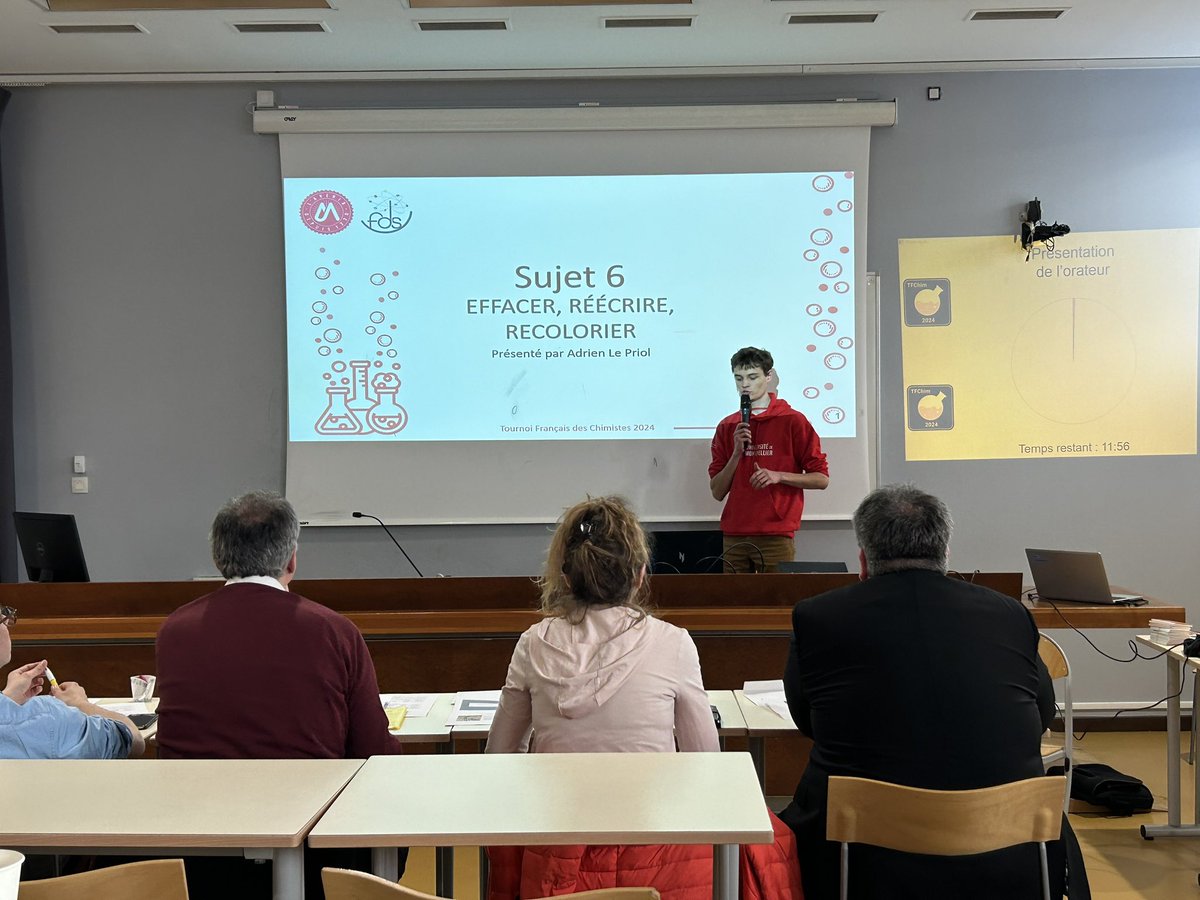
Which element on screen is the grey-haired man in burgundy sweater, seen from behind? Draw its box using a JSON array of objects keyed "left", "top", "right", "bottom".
[{"left": 156, "top": 491, "right": 400, "bottom": 760}]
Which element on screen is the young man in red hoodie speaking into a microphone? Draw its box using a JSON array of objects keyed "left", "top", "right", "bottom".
[{"left": 708, "top": 347, "right": 829, "bottom": 572}]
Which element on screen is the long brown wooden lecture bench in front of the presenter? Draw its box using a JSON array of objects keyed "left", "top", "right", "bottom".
[{"left": 0, "top": 572, "right": 1171, "bottom": 793}]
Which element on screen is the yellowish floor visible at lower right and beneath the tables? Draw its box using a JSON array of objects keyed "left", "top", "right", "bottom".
[{"left": 403, "top": 732, "right": 1200, "bottom": 900}]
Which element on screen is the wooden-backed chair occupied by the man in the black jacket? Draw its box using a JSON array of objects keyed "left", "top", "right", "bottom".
[{"left": 826, "top": 775, "right": 1067, "bottom": 900}]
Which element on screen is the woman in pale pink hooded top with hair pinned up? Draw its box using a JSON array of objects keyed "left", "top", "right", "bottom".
[{"left": 487, "top": 497, "right": 720, "bottom": 754}]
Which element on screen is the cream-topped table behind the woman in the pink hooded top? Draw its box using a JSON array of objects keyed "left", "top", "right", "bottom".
[{"left": 308, "top": 754, "right": 773, "bottom": 899}]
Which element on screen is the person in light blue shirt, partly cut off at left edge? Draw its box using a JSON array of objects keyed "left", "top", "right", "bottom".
[{"left": 0, "top": 606, "right": 145, "bottom": 760}]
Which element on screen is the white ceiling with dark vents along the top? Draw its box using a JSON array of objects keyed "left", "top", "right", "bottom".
[{"left": 0, "top": 0, "right": 1200, "bottom": 84}]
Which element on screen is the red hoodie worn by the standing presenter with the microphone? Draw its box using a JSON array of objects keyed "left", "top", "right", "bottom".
[{"left": 708, "top": 394, "right": 829, "bottom": 538}]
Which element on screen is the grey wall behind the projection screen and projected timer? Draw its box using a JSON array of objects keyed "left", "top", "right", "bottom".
[{"left": 0, "top": 70, "right": 1200, "bottom": 701}]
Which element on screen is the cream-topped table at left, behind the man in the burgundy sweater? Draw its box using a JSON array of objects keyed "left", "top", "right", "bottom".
[{"left": 0, "top": 760, "right": 362, "bottom": 900}]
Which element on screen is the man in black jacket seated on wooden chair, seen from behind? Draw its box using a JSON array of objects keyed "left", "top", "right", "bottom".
[{"left": 781, "top": 485, "right": 1088, "bottom": 900}]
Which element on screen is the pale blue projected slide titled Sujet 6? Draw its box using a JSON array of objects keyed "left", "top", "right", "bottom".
[{"left": 283, "top": 172, "right": 858, "bottom": 442}]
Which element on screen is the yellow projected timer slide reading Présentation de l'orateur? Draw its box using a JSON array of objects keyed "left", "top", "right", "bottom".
[{"left": 895, "top": 229, "right": 1200, "bottom": 460}]
